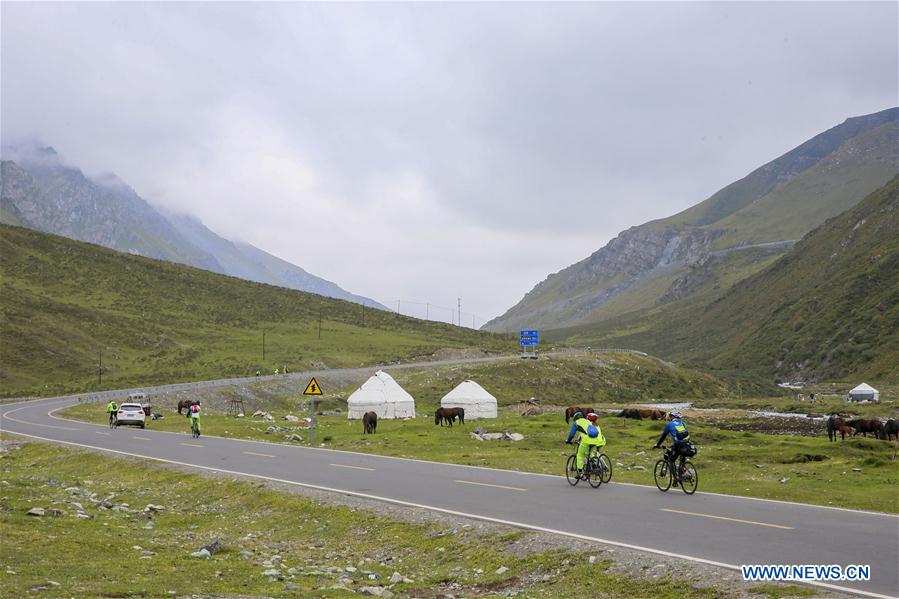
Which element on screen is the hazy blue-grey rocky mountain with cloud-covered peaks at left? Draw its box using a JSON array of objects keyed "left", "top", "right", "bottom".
[{"left": 0, "top": 147, "right": 386, "bottom": 310}]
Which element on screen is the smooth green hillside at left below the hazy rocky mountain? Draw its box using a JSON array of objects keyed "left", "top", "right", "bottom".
[{"left": 0, "top": 226, "right": 516, "bottom": 396}]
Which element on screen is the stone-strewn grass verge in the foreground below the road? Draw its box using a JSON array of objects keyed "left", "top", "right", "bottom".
[{"left": 0, "top": 443, "right": 740, "bottom": 598}]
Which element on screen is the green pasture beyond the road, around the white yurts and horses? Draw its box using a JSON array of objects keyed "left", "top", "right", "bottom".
[{"left": 61, "top": 368, "right": 899, "bottom": 512}]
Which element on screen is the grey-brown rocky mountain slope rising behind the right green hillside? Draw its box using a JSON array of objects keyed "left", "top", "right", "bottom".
[{"left": 484, "top": 108, "right": 899, "bottom": 331}]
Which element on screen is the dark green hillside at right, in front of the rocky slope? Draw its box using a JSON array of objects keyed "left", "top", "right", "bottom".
[{"left": 549, "top": 177, "right": 899, "bottom": 382}]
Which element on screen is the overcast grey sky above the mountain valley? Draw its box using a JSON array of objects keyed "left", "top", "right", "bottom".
[{"left": 0, "top": 2, "right": 897, "bottom": 326}]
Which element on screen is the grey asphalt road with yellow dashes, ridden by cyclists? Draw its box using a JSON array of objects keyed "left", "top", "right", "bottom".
[{"left": 0, "top": 397, "right": 899, "bottom": 597}]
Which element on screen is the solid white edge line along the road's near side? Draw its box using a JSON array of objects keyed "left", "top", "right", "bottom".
[{"left": 5, "top": 433, "right": 895, "bottom": 599}]
